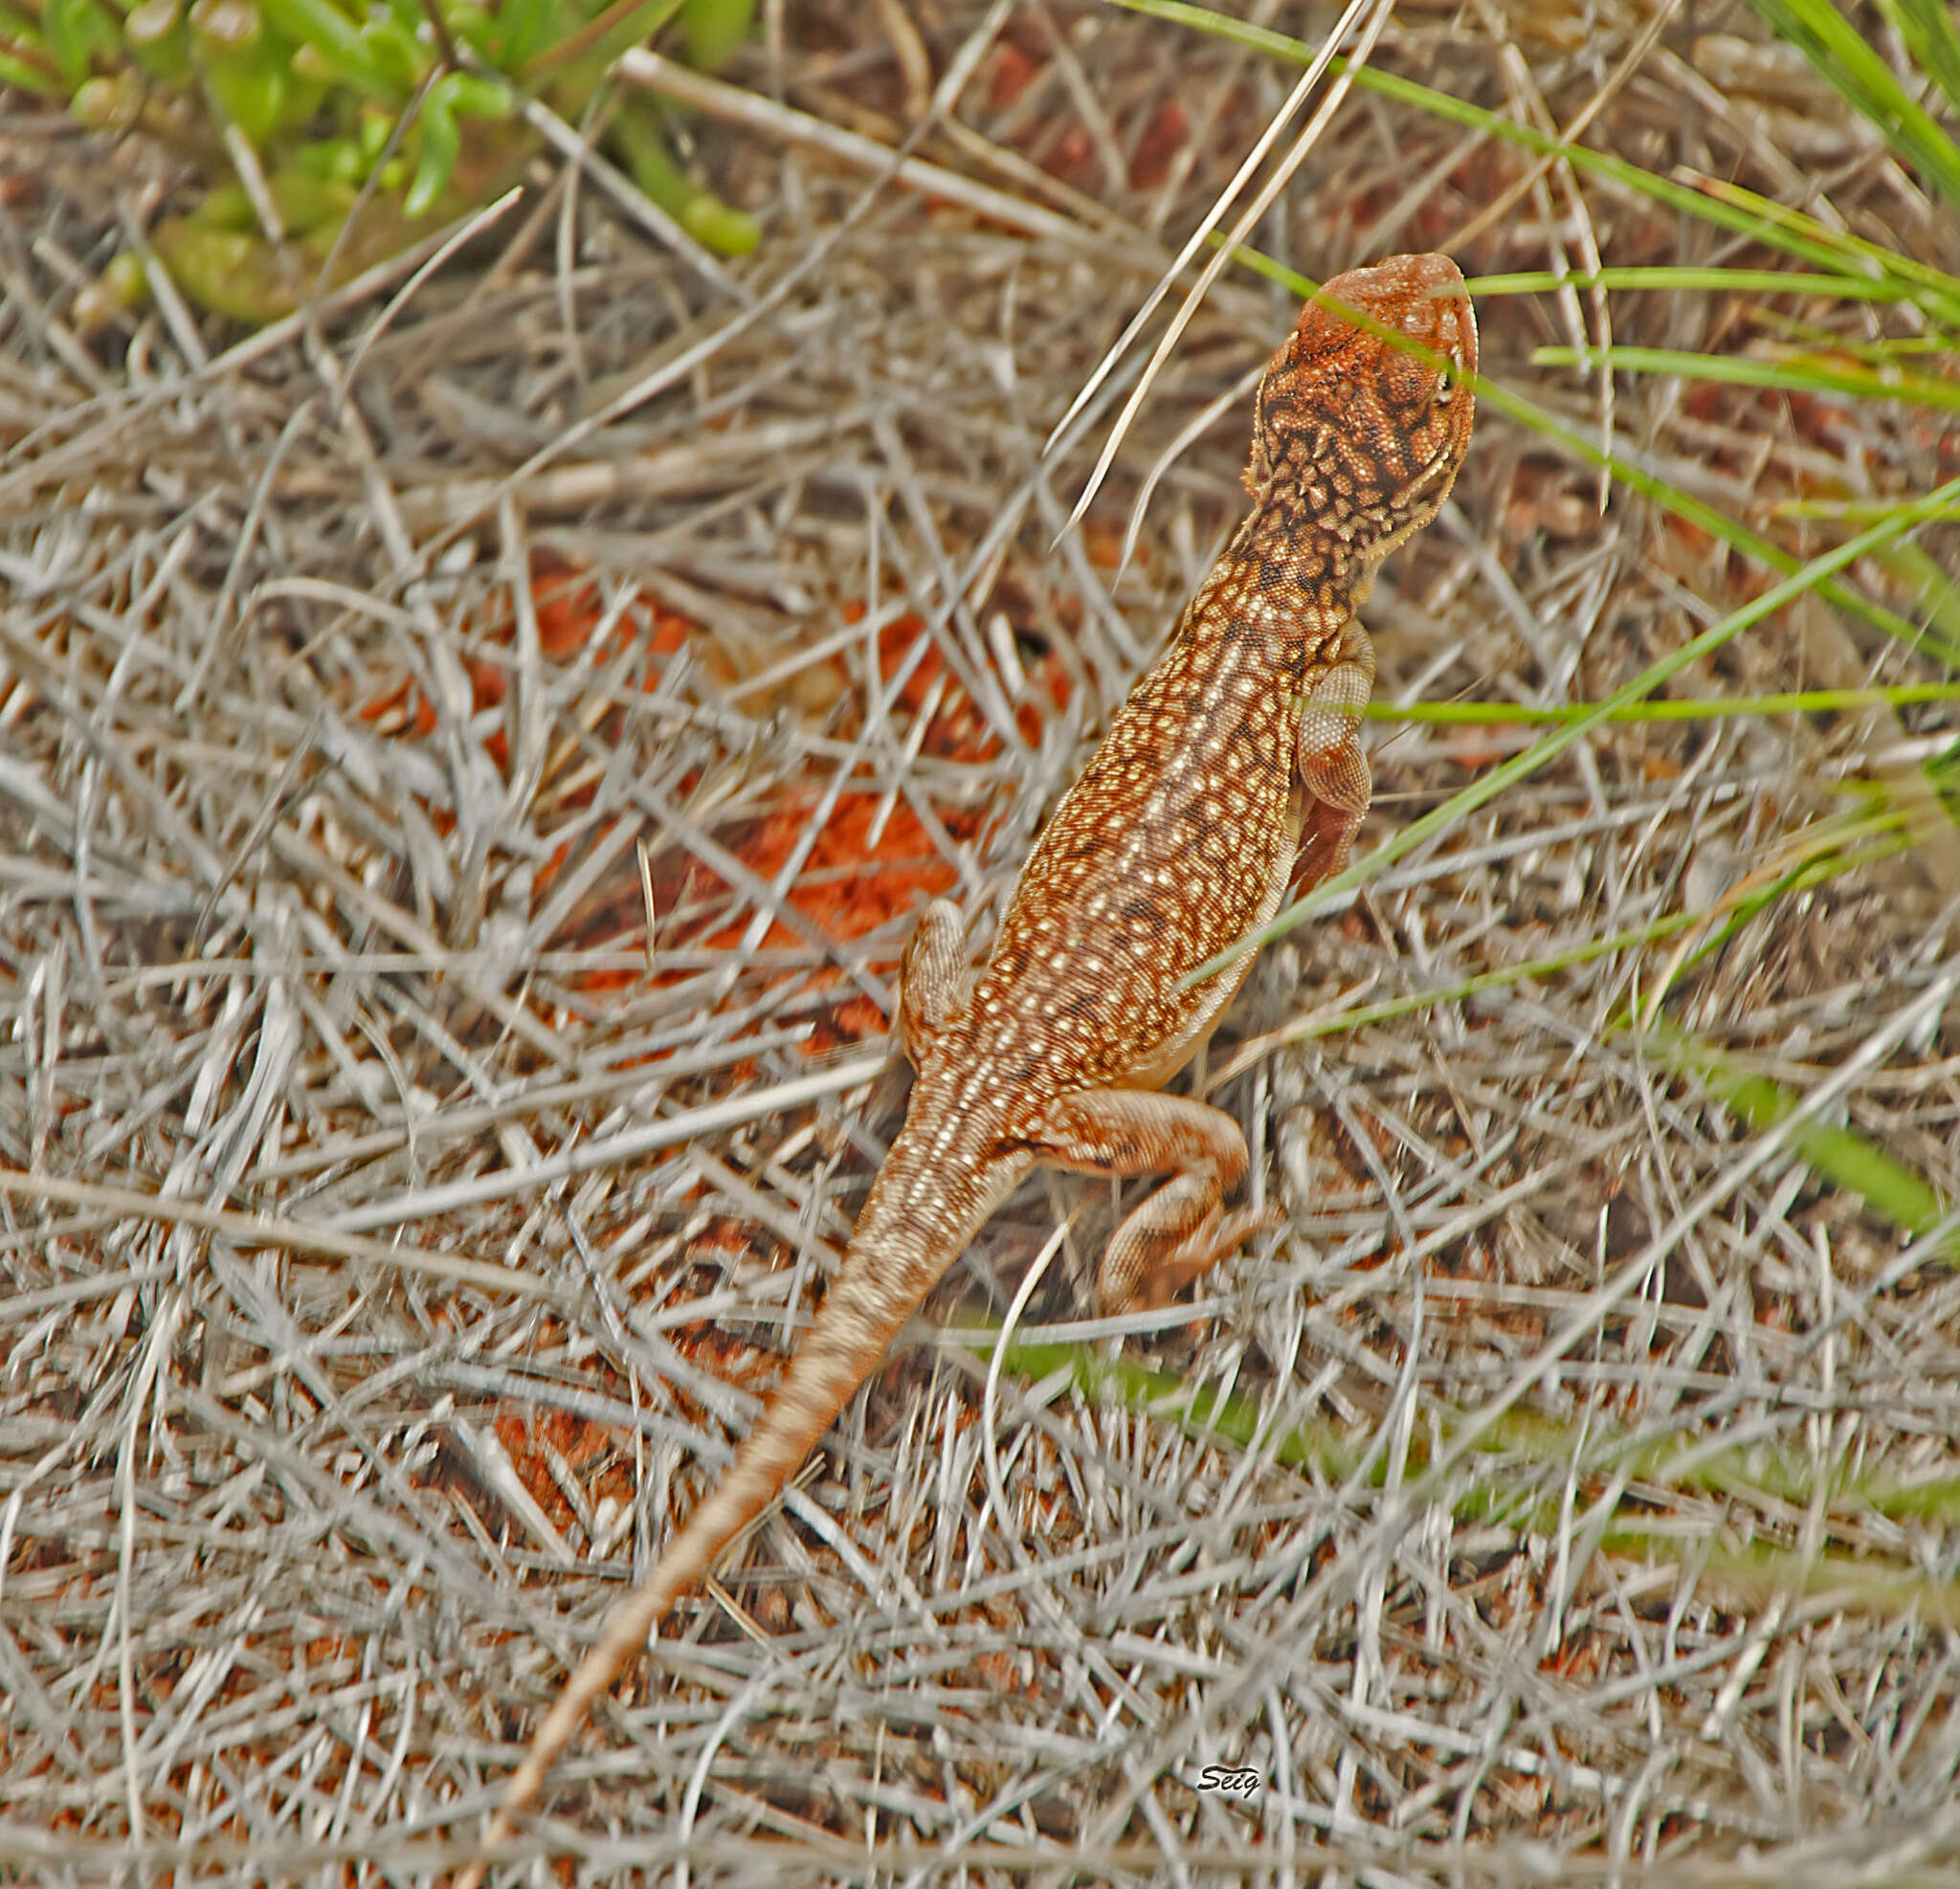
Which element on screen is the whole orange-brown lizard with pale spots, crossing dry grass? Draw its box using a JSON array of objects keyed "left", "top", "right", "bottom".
[{"left": 458, "top": 255, "right": 1476, "bottom": 1889}]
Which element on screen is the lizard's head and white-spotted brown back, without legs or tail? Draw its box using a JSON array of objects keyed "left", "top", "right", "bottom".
[{"left": 947, "top": 255, "right": 1476, "bottom": 1096}]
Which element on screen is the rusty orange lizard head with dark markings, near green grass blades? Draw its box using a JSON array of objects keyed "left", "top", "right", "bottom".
[{"left": 1244, "top": 255, "right": 1476, "bottom": 602}]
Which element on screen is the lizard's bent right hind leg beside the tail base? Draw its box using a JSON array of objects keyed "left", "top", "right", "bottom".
[{"left": 1029, "top": 1090, "right": 1283, "bottom": 1311}]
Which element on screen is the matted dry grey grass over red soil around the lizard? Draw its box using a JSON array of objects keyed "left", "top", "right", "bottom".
[{"left": 0, "top": 4, "right": 1960, "bottom": 1885}]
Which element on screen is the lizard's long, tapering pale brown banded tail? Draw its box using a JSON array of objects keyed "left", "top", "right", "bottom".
[{"left": 457, "top": 1131, "right": 1021, "bottom": 1889}]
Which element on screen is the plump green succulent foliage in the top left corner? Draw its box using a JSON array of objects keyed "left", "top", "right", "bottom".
[{"left": 0, "top": 0, "right": 757, "bottom": 322}]
